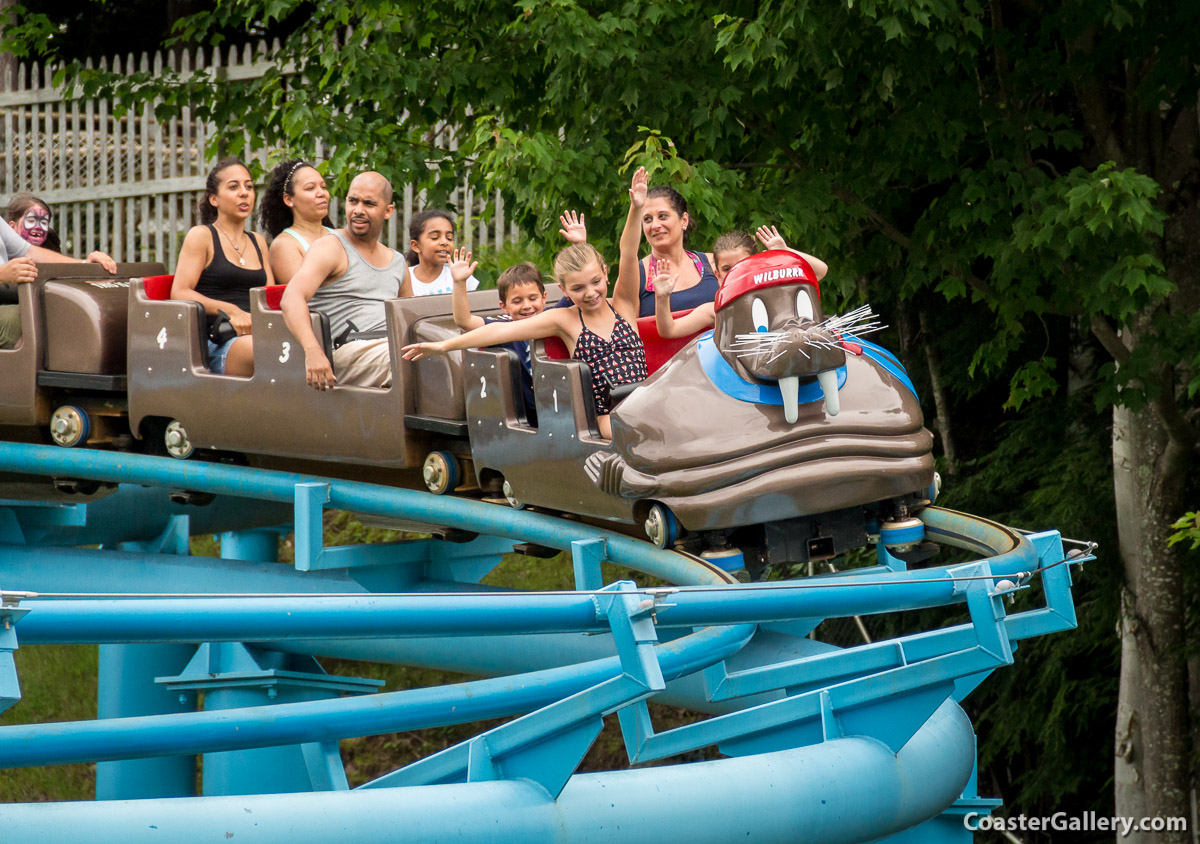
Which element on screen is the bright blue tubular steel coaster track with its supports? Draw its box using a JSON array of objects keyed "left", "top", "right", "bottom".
[{"left": 0, "top": 443, "right": 1091, "bottom": 844}]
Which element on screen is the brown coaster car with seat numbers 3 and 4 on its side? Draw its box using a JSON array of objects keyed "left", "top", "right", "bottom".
[{"left": 128, "top": 276, "right": 520, "bottom": 486}]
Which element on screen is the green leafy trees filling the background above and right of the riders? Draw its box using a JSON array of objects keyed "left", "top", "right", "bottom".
[{"left": 10, "top": 0, "right": 1200, "bottom": 840}]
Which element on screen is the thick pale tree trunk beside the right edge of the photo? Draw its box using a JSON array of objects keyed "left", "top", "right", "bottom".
[{"left": 1112, "top": 393, "right": 1192, "bottom": 844}]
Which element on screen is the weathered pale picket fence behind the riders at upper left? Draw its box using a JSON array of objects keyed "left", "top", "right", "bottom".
[{"left": 0, "top": 42, "right": 517, "bottom": 270}]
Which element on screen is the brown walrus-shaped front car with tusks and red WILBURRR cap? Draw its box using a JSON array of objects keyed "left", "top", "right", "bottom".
[{"left": 467, "top": 250, "right": 934, "bottom": 562}]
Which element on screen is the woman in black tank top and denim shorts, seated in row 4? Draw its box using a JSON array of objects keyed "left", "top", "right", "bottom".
[{"left": 170, "top": 158, "right": 275, "bottom": 377}]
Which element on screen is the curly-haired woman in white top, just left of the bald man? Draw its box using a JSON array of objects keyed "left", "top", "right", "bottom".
[{"left": 258, "top": 158, "right": 334, "bottom": 285}]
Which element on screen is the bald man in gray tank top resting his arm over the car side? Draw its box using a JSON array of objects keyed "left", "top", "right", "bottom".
[{"left": 280, "top": 172, "right": 408, "bottom": 390}]
